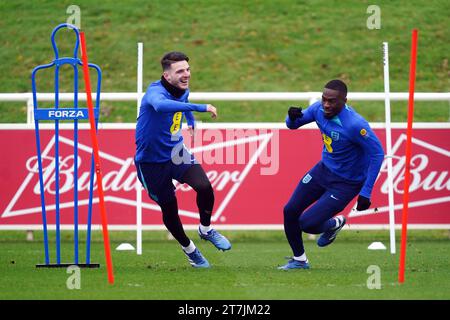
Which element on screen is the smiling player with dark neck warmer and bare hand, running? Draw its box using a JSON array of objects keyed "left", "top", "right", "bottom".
[{"left": 134, "top": 52, "right": 231, "bottom": 268}]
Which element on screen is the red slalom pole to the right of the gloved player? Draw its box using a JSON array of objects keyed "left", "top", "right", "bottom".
[{"left": 398, "top": 29, "right": 417, "bottom": 283}]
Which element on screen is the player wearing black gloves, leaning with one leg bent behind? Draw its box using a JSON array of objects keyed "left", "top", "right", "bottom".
[{"left": 279, "top": 80, "right": 384, "bottom": 270}]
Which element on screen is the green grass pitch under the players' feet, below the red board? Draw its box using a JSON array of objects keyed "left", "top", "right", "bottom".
[{"left": 0, "top": 230, "right": 450, "bottom": 300}]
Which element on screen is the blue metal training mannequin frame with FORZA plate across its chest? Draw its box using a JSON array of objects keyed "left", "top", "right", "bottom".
[{"left": 31, "top": 23, "right": 102, "bottom": 268}]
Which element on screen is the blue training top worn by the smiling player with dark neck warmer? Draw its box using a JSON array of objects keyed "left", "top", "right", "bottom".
[{"left": 135, "top": 80, "right": 207, "bottom": 163}]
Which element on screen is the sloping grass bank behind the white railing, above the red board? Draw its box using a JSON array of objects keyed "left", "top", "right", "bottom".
[{"left": 0, "top": 0, "right": 450, "bottom": 123}]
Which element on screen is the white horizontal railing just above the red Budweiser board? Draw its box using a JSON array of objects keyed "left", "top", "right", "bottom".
[{"left": 0, "top": 92, "right": 450, "bottom": 124}]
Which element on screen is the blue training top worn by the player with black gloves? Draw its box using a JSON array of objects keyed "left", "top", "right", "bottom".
[{"left": 286, "top": 101, "right": 384, "bottom": 198}]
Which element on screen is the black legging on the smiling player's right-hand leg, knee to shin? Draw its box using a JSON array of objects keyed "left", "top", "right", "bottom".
[{"left": 180, "top": 164, "right": 214, "bottom": 227}]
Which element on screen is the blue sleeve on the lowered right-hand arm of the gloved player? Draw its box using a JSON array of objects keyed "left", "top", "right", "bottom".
[{"left": 352, "top": 120, "right": 384, "bottom": 199}]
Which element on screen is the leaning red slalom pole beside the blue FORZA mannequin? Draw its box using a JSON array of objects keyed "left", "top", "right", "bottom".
[{"left": 80, "top": 32, "right": 114, "bottom": 284}]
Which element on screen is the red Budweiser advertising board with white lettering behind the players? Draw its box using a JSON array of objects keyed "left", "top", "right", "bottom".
[{"left": 0, "top": 123, "right": 450, "bottom": 230}]
